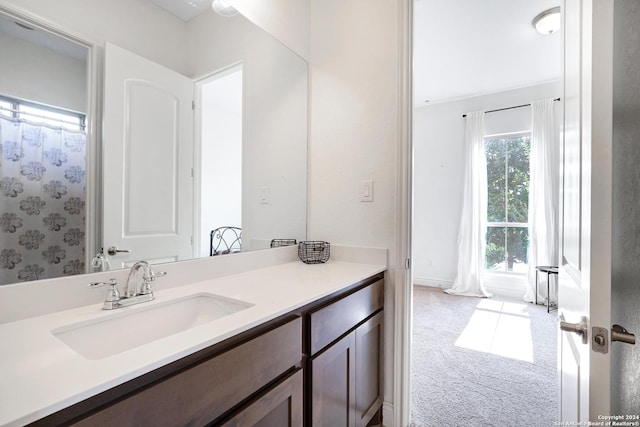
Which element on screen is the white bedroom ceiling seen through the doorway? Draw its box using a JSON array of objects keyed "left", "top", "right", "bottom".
[{"left": 413, "top": 0, "right": 562, "bottom": 106}]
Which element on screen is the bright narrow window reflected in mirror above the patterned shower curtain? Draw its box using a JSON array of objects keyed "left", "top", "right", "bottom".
[{"left": 0, "top": 96, "right": 85, "bottom": 131}]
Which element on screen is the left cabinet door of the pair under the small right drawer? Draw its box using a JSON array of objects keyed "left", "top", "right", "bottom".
[{"left": 311, "top": 332, "right": 356, "bottom": 427}]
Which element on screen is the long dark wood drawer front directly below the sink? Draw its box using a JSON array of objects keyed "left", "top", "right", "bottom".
[{"left": 75, "top": 318, "right": 302, "bottom": 426}]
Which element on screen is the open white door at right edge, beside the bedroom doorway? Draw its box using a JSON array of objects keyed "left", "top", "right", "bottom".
[{"left": 558, "top": 0, "right": 613, "bottom": 421}]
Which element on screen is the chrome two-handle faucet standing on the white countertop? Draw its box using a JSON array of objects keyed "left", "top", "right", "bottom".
[{"left": 89, "top": 261, "right": 167, "bottom": 310}]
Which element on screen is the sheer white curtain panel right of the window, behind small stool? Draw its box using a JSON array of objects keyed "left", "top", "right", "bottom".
[{"left": 524, "top": 99, "right": 560, "bottom": 303}]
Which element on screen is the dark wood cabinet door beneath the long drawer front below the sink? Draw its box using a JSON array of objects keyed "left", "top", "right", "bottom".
[{"left": 222, "top": 369, "right": 303, "bottom": 427}]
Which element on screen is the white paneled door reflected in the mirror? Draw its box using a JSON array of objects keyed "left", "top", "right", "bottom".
[{"left": 102, "top": 43, "right": 194, "bottom": 268}]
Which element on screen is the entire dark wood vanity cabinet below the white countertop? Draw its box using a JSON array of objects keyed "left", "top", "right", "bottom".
[{"left": 32, "top": 273, "right": 384, "bottom": 427}]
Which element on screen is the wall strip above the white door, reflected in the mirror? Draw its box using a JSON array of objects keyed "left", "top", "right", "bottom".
[{"left": 0, "top": 0, "right": 187, "bottom": 74}]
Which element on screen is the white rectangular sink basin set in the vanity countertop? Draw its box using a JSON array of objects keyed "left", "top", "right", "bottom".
[{"left": 51, "top": 293, "right": 253, "bottom": 360}]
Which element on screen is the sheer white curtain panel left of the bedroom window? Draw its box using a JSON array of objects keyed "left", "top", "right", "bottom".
[{"left": 445, "top": 111, "right": 491, "bottom": 297}]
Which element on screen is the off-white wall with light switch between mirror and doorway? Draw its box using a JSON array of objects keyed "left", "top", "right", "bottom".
[{"left": 308, "top": 0, "right": 403, "bottom": 412}]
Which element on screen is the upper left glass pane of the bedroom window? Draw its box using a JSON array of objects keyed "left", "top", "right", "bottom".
[{"left": 485, "top": 139, "right": 507, "bottom": 222}]
